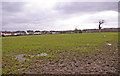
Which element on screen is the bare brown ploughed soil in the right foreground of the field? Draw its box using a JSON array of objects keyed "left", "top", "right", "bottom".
[{"left": 23, "top": 41, "right": 118, "bottom": 74}]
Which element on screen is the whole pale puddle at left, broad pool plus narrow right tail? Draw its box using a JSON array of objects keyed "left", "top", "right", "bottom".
[{"left": 12, "top": 53, "right": 48, "bottom": 62}]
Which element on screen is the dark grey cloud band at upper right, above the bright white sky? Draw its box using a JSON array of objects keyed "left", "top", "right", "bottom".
[{"left": 55, "top": 2, "right": 118, "bottom": 14}]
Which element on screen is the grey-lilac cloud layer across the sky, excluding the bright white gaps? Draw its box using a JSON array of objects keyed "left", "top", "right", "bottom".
[{"left": 2, "top": 2, "right": 117, "bottom": 30}]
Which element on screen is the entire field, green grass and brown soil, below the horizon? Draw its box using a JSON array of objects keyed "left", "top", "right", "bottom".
[{"left": 2, "top": 33, "right": 118, "bottom": 74}]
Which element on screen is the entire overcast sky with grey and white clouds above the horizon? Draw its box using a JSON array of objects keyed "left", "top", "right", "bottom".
[{"left": 2, "top": 2, "right": 118, "bottom": 31}]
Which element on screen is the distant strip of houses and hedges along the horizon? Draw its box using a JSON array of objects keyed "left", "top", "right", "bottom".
[{"left": 0, "top": 28, "right": 120, "bottom": 37}]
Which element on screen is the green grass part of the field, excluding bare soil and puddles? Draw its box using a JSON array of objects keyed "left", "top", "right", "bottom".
[{"left": 2, "top": 33, "right": 118, "bottom": 74}]
